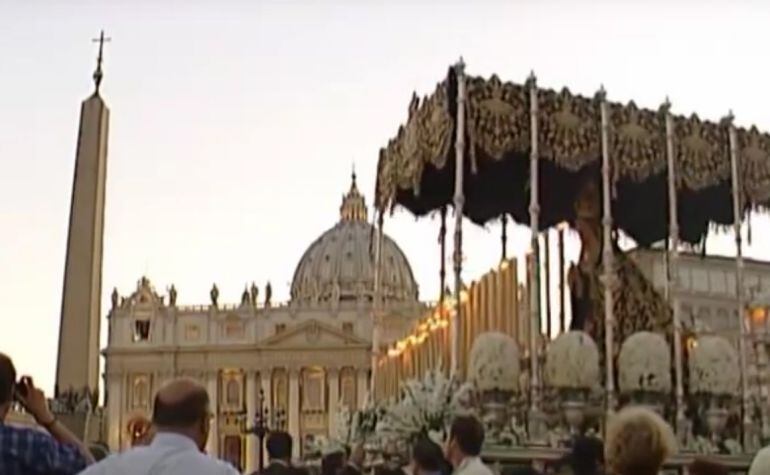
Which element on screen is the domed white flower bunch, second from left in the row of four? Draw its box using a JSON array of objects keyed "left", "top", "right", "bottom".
[{"left": 545, "top": 331, "right": 599, "bottom": 389}]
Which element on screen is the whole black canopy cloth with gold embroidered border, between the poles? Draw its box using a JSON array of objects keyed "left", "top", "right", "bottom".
[{"left": 375, "top": 68, "right": 770, "bottom": 246}]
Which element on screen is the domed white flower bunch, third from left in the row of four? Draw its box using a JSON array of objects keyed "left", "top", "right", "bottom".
[{"left": 618, "top": 332, "right": 671, "bottom": 393}]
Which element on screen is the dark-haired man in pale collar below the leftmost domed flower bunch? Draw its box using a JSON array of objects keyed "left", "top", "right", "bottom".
[{"left": 444, "top": 416, "right": 492, "bottom": 475}]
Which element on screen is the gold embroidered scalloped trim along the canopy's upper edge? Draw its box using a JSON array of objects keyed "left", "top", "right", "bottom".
[{"left": 375, "top": 70, "right": 770, "bottom": 211}]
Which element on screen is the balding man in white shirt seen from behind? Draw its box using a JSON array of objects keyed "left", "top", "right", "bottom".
[{"left": 81, "top": 379, "right": 238, "bottom": 475}]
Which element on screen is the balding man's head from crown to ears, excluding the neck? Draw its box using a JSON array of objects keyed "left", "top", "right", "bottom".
[{"left": 152, "top": 379, "right": 209, "bottom": 429}]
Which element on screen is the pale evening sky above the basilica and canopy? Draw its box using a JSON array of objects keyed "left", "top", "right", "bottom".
[{"left": 0, "top": 0, "right": 770, "bottom": 391}]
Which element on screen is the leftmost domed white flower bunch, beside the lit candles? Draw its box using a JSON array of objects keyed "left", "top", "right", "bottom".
[{"left": 468, "top": 332, "right": 520, "bottom": 391}]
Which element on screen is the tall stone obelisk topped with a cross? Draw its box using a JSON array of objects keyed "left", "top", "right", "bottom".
[{"left": 56, "top": 32, "right": 110, "bottom": 398}]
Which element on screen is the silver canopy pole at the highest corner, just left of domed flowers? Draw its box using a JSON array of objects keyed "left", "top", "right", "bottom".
[{"left": 449, "top": 58, "right": 465, "bottom": 376}]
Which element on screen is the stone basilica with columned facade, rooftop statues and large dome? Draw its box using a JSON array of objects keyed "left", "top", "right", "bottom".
[{"left": 103, "top": 175, "right": 425, "bottom": 470}]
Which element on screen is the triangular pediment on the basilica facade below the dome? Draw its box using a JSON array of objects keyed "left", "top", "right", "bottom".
[{"left": 260, "top": 320, "right": 369, "bottom": 348}]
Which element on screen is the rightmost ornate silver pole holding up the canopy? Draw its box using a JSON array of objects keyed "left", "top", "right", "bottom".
[{"left": 727, "top": 112, "right": 752, "bottom": 450}]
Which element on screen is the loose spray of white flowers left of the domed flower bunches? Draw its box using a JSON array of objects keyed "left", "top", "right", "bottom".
[{"left": 377, "top": 369, "right": 473, "bottom": 443}]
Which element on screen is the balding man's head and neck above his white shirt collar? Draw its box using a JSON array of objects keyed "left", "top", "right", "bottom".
[{"left": 152, "top": 379, "right": 211, "bottom": 450}]
